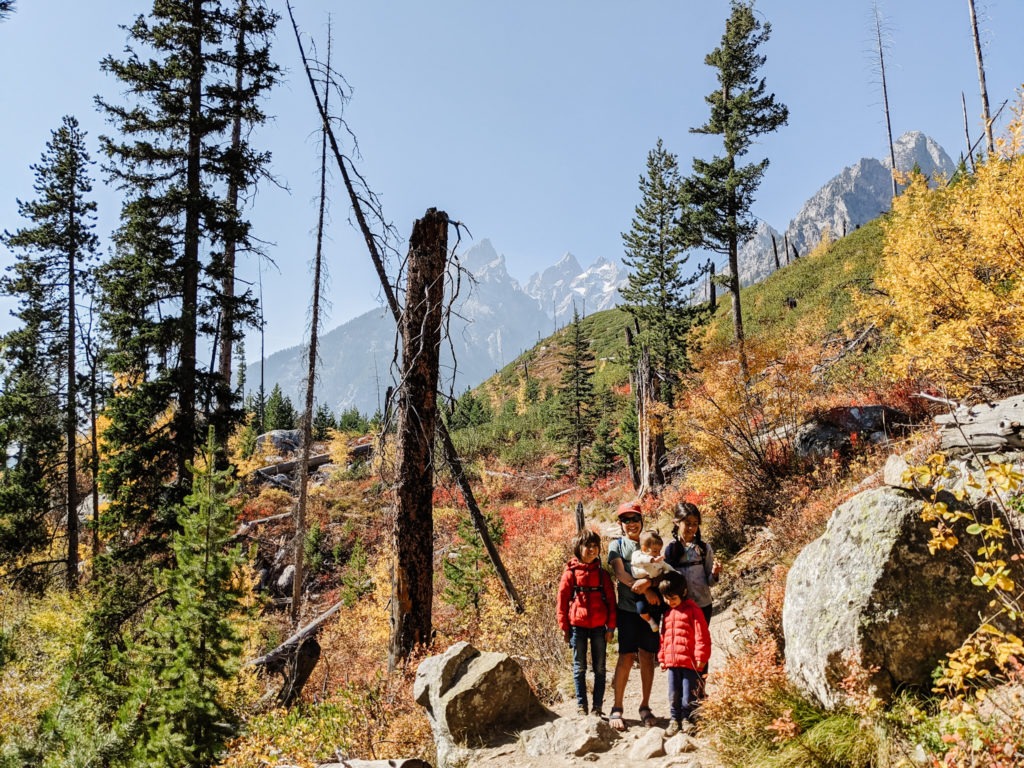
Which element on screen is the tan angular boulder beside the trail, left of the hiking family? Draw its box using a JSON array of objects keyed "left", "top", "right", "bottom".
[{"left": 413, "top": 642, "right": 546, "bottom": 768}]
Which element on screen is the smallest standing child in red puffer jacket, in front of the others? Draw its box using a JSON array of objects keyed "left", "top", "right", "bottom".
[{"left": 657, "top": 573, "right": 711, "bottom": 736}]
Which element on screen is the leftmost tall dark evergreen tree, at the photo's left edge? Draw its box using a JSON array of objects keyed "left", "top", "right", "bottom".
[{"left": 0, "top": 116, "right": 98, "bottom": 589}]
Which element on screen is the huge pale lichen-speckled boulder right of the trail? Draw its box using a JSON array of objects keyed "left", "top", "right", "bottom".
[{"left": 782, "top": 486, "right": 989, "bottom": 709}]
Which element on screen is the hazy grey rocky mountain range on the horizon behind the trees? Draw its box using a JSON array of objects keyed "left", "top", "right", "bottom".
[{"left": 248, "top": 131, "right": 955, "bottom": 415}]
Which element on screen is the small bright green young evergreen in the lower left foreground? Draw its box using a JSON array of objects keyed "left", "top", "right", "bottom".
[{"left": 122, "top": 439, "right": 243, "bottom": 768}]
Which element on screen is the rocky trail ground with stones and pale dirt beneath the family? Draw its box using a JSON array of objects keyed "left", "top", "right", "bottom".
[{"left": 467, "top": 609, "right": 735, "bottom": 768}]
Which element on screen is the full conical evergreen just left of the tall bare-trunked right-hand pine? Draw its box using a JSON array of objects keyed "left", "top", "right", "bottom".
[{"left": 622, "top": 139, "right": 701, "bottom": 403}]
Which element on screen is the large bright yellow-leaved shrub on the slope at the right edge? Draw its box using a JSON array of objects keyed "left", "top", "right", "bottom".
[{"left": 861, "top": 97, "right": 1024, "bottom": 396}]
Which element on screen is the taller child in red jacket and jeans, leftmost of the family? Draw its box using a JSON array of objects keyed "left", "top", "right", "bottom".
[{"left": 558, "top": 529, "right": 615, "bottom": 717}]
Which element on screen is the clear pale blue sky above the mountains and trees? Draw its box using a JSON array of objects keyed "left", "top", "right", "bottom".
[{"left": 0, "top": 0, "right": 1024, "bottom": 358}]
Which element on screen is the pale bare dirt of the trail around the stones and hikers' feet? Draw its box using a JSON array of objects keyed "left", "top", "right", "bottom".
[{"left": 468, "top": 608, "right": 735, "bottom": 768}]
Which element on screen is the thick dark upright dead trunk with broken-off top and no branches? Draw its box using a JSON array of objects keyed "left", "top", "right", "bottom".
[{"left": 388, "top": 208, "right": 449, "bottom": 671}]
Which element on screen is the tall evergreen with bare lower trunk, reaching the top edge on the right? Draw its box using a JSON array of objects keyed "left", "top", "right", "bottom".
[{"left": 683, "top": 0, "right": 790, "bottom": 380}]
